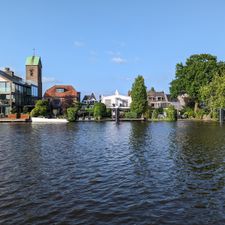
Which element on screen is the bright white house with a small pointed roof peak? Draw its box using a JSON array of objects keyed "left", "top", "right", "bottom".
[{"left": 101, "top": 90, "right": 131, "bottom": 109}]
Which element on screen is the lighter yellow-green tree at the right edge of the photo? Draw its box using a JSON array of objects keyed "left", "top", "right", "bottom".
[{"left": 200, "top": 73, "right": 225, "bottom": 113}]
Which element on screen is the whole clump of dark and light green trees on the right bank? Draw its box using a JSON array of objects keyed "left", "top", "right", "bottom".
[{"left": 170, "top": 54, "right": 225, "bottom": 117}]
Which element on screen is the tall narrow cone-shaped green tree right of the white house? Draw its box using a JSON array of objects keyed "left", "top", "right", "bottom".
[{"left": 131, "top": 75, "right": 148, "bottom": 117}]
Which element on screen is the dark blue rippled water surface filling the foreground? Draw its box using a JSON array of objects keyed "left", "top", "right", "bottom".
[{"left": 0, "top": 121, "right": 225, "bottom": 225}]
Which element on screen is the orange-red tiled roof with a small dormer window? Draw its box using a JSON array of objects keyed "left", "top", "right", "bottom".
[{"left": 44, "top": 85, "right": 80, "bottom": 98}]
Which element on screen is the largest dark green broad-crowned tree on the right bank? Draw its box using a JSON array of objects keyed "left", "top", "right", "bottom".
[{"left": 170, "top": 54, "right": 225, "bottom": 111}]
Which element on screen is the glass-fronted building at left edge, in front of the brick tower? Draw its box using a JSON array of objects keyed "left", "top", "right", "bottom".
[{"left": 0, "top": 68, "right": 38, "bottom": 117}]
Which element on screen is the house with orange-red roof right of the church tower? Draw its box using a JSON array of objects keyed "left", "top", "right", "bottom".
[{"left": 44, "top": 85, "right": 80, "bottom": 114}]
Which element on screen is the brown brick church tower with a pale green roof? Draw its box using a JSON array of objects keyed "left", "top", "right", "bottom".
[{"left": 26, "top": 56, "right": 42, "bottom": 99}]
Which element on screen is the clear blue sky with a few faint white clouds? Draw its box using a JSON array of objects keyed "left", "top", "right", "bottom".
[{"left": 0, "top": 0, "right": 225, "bottom": 96}]
